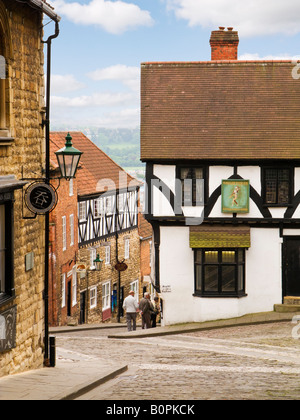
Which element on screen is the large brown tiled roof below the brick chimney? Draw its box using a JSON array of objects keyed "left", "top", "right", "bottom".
[{"left": 141, "top": 60, "right": 300, "bottom": 161}]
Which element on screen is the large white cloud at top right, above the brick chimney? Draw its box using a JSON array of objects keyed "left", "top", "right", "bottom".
[{"left": 165, "top": 0, "right": 300, "bottom": 37}]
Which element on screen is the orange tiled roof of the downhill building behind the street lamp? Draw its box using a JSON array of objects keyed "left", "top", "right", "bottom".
[{"left": 50, "top": 132, "right": 141, "bottom": 195}]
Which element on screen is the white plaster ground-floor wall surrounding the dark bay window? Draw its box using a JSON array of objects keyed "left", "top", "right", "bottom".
[{"left": 160, "top": 227, "right": 282, "bottom": 325}]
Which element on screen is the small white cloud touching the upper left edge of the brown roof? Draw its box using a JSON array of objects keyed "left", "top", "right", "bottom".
[{"left": 88, "top": 64, "right": 140, "bottom": 92}]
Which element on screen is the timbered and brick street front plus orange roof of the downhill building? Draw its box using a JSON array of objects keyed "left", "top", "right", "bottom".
[{"left": 51, "top": 132, "right": 142, "bottom": 323}]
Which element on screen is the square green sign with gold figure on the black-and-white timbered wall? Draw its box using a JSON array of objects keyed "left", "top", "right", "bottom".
[{"left": 222, "top": 179, "right": 250, "bottom": 213}]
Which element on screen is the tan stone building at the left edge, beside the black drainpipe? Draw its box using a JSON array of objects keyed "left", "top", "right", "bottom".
[{"left": 0, "top": 0, "right": 57, "bottom": 376}]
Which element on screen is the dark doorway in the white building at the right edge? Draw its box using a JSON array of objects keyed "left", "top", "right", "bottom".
[{"left": 283, "top": 237, "right": 300, "bottom": 296}]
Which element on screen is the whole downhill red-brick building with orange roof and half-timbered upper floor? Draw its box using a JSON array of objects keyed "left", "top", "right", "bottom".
[{"left": 51, "top": 132, "right": 142, "bottom": 325}]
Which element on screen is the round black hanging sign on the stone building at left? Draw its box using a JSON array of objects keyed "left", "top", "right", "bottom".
[{"left": 25, "top": 182, "right": 57, "bottom": 214}]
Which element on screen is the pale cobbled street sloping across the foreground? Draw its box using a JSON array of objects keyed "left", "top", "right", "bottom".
[{"left": 56, "top": 322, "right": 300, "bottom": 401}]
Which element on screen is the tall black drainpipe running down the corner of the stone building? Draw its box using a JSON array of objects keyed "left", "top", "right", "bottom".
[{"left": 42, "top": 21, "right": 59, "bottom": 366}]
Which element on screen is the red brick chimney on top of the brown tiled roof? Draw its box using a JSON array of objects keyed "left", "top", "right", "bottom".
[{"left": 210, "top": 26, "right": 239, "bottom": 60}]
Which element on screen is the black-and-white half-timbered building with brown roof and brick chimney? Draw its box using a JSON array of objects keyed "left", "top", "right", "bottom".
[{"left": 141, "top": 28, "right": 300, "bottom": 324}]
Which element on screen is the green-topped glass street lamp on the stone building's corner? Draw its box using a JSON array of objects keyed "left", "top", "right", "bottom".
[{"left": 55, "top": 133, "right": 82, "bottom": 181}]
